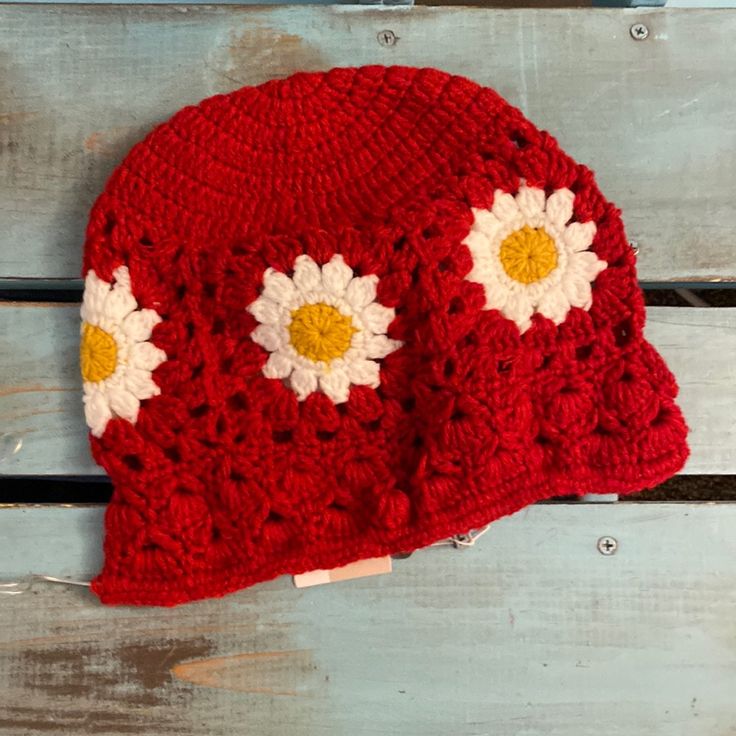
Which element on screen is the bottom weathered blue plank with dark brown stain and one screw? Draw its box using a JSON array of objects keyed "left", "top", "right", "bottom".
[{"left": 0, "top": 504, "right": 736, "bottom": 736}]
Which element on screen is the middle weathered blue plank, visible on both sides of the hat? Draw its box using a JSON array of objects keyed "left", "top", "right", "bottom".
[{"left": 0, "top": 303, "right": 736, "bottom": 475}]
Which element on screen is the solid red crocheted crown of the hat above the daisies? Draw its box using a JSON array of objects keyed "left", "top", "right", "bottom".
[{"left": 83, "top": 66, "right": 506, "bottom": 246}]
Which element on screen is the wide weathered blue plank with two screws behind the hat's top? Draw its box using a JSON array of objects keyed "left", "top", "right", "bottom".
[{"left": 0, "top": 5, "right": 736, "bottom": 282}]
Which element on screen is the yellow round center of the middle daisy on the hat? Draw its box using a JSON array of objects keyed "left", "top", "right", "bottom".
[{"left": 289, "top": 302, "right": 357, "bottom": 363}]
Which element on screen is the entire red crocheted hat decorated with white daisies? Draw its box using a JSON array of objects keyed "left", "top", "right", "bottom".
[{"left": 81, "top": 66, "right": 688, "bottom": 605}]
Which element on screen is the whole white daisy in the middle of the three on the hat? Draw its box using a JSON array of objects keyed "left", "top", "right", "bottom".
[{"left": 248, "top": 255, "right": 402, "bottom": 404}]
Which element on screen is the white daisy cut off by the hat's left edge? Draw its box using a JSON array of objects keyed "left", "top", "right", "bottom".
[{"left": 79, "top": 266, "right": 166, "bottom": 437}]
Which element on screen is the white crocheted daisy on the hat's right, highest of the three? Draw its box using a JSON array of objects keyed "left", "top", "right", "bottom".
[{"left": 463, "top": 185, "right": 608, "bottom": 332}]
